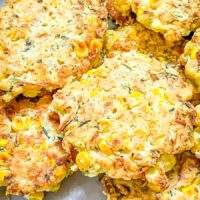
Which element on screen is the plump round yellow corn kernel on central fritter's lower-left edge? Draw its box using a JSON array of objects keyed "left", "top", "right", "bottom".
[{"left": 76, "top": 151, "right": 92, "bottom": 170}]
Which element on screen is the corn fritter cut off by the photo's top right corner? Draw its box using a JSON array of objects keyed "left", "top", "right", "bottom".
[{"left": 132, "top": 0, "right": 200, "bottom": 41}]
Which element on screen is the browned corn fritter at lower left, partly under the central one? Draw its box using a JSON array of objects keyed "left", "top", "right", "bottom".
[{"left": 0, "top": 95, "right": 74, "bottom": 199}]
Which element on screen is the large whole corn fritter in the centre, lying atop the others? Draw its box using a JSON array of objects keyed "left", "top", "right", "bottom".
[{"left": 49, "top": 51, "right": 194, "bottom": 179}]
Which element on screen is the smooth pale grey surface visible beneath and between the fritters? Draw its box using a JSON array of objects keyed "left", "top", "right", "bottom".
[{"left": 0, "top": 0, "right": 106, "bottom": 200}]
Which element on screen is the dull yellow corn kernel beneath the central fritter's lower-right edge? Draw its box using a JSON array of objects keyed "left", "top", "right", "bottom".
[{"left": 157, "top": 154, "right": 176, "bottom": 172}]
